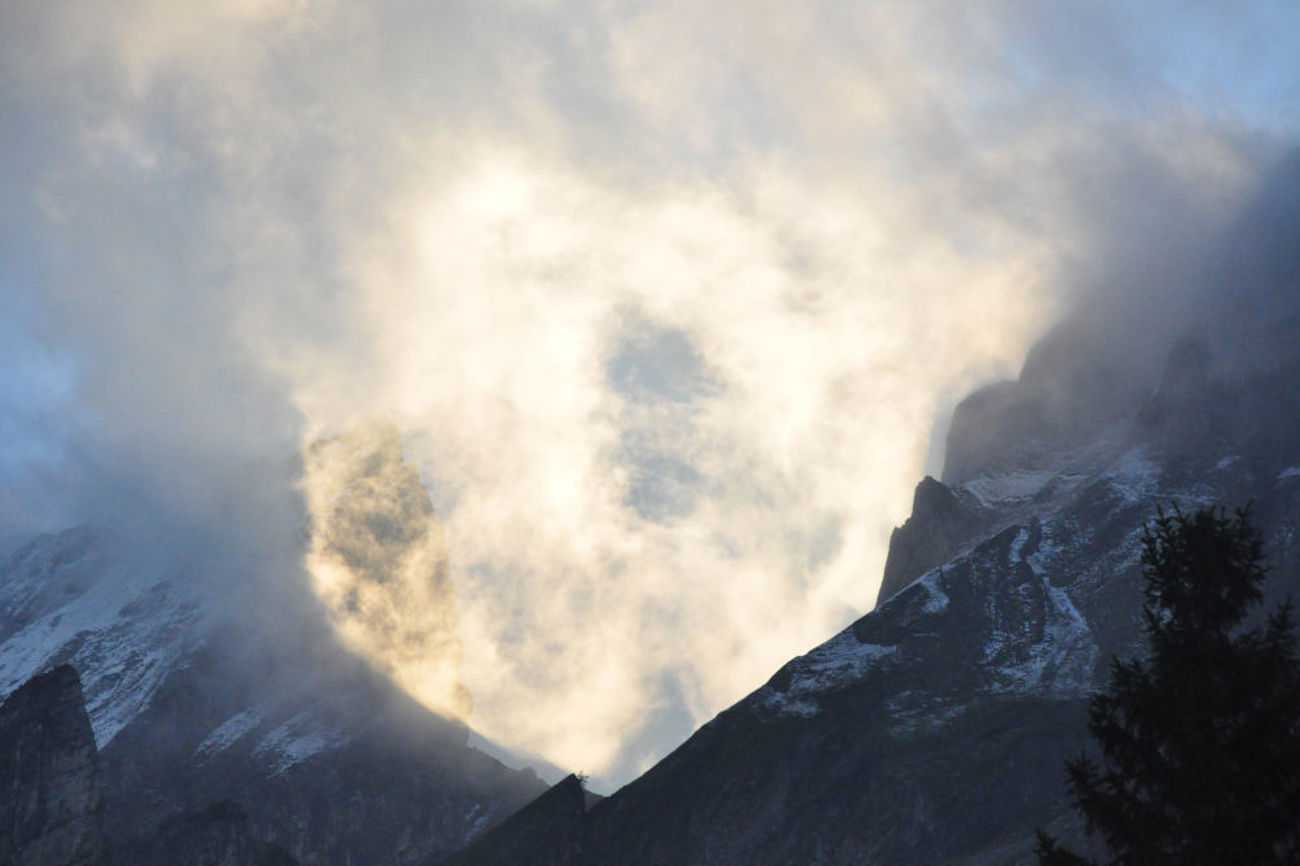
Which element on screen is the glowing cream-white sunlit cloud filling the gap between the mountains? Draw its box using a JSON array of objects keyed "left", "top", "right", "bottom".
[{"left": 282, "top": 144, "right": 1045, "bottom": 774}]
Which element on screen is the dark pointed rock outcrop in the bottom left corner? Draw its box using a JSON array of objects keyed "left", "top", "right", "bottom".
[{"left": 0, "top": 664, "right": 104, "bottom": 866}]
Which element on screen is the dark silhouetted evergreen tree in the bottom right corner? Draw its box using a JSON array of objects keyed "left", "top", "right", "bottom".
[{"left": 1039, "top": 508, "right": 1300, "bottom": 866}]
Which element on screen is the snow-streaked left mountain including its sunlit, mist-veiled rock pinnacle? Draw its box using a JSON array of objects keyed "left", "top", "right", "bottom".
[{"left": 0, "top": 430, "right": 545, "bottom": 866}]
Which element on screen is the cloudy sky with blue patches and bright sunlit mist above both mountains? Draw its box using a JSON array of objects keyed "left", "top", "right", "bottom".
[{"left": 0, "top": 0, "right": 1300, "bottom": 788}]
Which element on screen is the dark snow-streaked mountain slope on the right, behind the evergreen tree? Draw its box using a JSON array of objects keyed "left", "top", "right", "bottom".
[{"left": 445, "top": 161, "right": 1300, "bottom": 866}]
